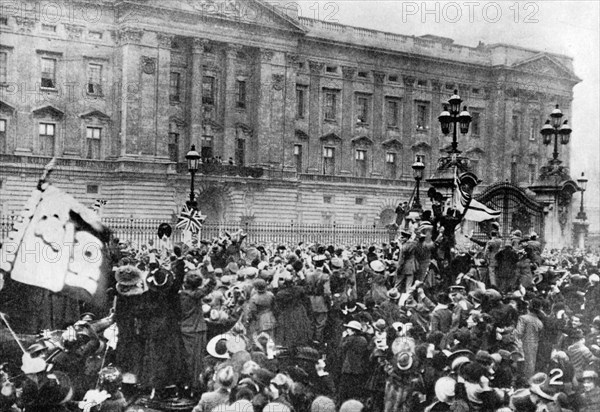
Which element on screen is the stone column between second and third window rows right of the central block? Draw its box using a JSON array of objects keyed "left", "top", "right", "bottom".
[{"left": 336, "top": 66, "right": 356, "bottom": 176}]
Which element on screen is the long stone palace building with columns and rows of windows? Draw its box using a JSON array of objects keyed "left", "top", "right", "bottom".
[{"left": 0, "top": 0, "right": 580, "bottom": 225}]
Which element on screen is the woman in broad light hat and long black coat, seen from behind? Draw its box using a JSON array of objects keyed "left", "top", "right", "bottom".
[{"left": 115, "top": 265, "right": 148, "bottom": 382}]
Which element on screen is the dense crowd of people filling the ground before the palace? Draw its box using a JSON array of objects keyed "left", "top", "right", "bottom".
[{"left": 0, "top": 219, "right": 600, "bottom": 412}]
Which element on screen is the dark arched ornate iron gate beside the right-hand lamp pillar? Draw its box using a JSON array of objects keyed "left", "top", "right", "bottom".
[{"left": 474, "top": 182, "right": 544, "bottom": 242}]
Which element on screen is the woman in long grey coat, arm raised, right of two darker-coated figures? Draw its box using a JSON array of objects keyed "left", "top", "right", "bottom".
[{"left": 179, "top": 270, "right": 216, "bottom": 391}]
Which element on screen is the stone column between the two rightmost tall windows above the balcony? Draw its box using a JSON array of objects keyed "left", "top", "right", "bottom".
[{"left": 221, "top": 44, "right": 242, "bottom": 160}]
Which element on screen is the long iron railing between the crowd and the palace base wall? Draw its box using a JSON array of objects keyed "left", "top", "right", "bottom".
[{"left": 0, "top": 216, "right": 396, "bottom": 246}]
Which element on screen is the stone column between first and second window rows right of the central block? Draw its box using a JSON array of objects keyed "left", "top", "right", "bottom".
[{"left": 308, "top": 60, "right": 324, "bottom": 173}]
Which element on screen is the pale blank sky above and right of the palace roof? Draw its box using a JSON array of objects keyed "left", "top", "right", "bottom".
[{"left": 290, "top": 0, "right": 600, "bottom": 231}]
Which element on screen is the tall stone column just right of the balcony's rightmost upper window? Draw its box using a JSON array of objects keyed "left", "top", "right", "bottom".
[{"left": 253, "top": 49, "right": 274, "bottom": 165}]
